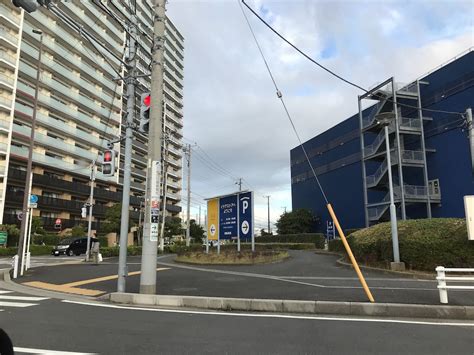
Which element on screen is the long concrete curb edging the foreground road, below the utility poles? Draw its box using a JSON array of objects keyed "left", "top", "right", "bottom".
[{"left": 109, "top": 292, "right": 474, "bottom": 320}]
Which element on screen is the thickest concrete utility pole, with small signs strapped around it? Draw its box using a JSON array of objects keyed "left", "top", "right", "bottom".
[{"left": 140, "top": 0, "right": 166, "bottom": 294}]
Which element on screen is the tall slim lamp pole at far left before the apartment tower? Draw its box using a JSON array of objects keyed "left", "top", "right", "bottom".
[{"left": 18, "top": 30, "right": 43, "bottom": 275}]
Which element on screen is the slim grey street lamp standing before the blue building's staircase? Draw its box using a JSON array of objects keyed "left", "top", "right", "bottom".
[{"left": 376, "top": 112, "right": 401, "bottom": 266}]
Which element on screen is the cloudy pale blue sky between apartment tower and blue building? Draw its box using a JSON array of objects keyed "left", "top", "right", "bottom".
[{"left": 167, "top": 0, "right": 474, "bottom": 231}]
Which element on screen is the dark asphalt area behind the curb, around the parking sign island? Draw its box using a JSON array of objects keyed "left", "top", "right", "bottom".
[{"left": 19, "top": 251, "right": 474, "bottom": 305}]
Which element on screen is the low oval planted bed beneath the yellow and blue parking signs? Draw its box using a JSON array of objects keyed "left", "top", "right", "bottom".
[{"left": 175, "top": 250, "right": 289, "bottom": 265}]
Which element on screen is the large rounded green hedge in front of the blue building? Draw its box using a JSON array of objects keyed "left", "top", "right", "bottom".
[{"left": 329, "top": 218, "right": 474, "bottom": 271}]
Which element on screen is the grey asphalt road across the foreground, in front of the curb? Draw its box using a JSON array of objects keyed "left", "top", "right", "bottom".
[{"left": 0, "top": 286, "right": 474, "bottom": 355}]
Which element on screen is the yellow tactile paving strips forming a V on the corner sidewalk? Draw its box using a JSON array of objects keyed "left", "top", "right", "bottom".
[{"left": 23, "top": 267, "right": 169, "bottom": 296}]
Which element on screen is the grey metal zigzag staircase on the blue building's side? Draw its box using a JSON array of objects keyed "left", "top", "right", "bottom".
[{"left": 359, "top": 78, "right": 441, "bottom": 226}]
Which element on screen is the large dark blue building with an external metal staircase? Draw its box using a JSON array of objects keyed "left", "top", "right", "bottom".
[{"left": 290, "top": 49, "right": 474, "bottom": 234}]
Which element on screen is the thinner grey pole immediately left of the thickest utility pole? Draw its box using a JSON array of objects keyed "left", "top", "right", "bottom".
[{"left": 117, "top": 14, "right": 137, "bottom": 292}]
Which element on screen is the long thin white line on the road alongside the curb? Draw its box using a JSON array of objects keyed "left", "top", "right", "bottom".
[{"left": 61, "top": 300, "right": 474, "bottom": 328}]
